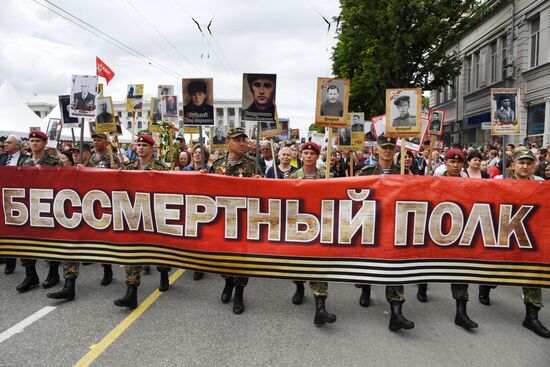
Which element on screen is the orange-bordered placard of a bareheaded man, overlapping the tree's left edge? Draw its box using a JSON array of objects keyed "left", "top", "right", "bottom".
[{"left": 315, "top": 78, "right": 349, "bottom": 127}]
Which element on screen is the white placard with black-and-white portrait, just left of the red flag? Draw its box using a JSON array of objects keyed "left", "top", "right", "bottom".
[{"left": 69, "top": 75, "right": 97, "bottom": 118}]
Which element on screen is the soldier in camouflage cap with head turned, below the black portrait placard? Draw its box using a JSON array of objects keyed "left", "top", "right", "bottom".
[{"left": 210, "top": 128, "right": 260, "bottom": 315}]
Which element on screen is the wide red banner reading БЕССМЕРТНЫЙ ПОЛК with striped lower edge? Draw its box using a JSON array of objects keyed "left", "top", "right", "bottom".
[{"left": 0, "top": 167, "right": 550, "bottom": 287}]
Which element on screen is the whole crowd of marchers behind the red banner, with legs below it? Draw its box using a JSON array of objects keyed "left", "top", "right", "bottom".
[{"left": 0, "top": 128, "right": 550, "bottom": 338}]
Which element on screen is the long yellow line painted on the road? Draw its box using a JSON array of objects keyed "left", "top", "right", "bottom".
[{"left": 75, "top": 269, "right": 185, "bottom": 367}]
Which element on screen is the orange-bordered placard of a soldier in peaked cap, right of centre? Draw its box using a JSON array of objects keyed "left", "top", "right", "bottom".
[{"left": 386, "top": 88, "right": 422, "bottom": 138}]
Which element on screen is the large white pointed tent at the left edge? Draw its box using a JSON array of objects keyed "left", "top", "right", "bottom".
[{"left": 0, "top": 80, "right": 46, "bottom": 137}]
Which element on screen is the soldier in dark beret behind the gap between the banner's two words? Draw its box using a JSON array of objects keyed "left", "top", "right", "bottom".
[{"left": 357, "top": 135, "right": 414, "bottom": 331}]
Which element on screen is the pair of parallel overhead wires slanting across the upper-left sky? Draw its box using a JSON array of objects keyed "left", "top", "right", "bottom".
[{"left": 32, "top": 0, "right": 180, "bottom": 78}]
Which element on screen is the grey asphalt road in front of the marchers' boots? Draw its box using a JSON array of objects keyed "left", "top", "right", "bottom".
[{"left": 0, "top": 261, "right": 550, "bottom": 367}]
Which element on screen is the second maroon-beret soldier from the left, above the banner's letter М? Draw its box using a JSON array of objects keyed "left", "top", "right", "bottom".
[{"left": 115, "top": 134, "right": 170, "bottom": 309}]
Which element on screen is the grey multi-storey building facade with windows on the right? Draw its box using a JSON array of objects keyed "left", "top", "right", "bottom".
[{"left": 430, "top": 0, "right": 550, "bottom": 146}]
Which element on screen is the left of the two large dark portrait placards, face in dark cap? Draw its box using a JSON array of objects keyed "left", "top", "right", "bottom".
[{"left": 182, "top": 78, "right": 214, "bottom": 126}]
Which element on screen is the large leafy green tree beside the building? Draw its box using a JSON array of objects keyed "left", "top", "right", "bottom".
[{"left": 332, "top": 0, "right": 488, "bottom": 116}]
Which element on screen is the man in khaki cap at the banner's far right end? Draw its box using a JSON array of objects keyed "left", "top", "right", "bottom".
[{"left": 479, "top": 149, "right": 550, "bottom": 338}]
